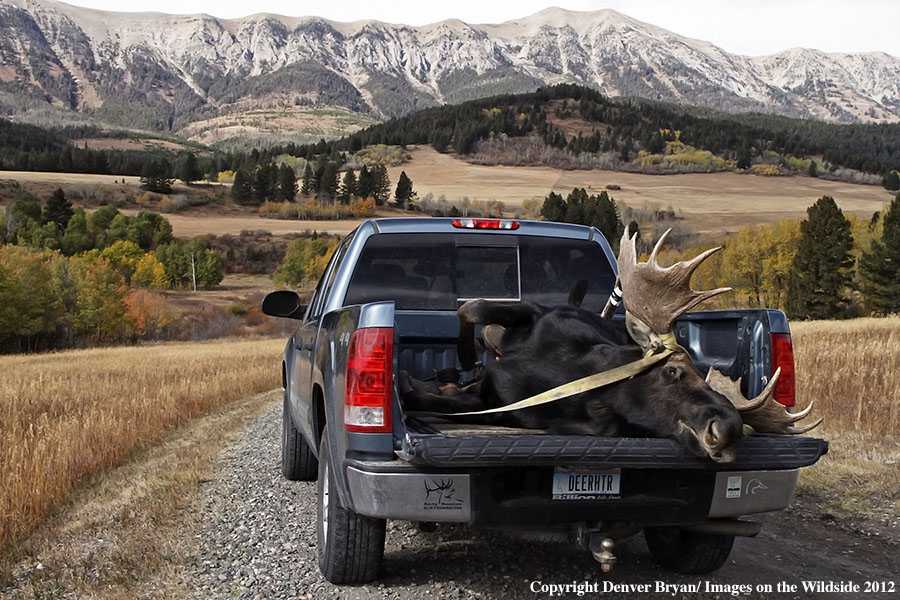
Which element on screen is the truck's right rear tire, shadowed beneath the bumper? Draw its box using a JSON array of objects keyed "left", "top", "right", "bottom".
[{"left": 644, "top": 527, "right": 734, "bottom": 575}]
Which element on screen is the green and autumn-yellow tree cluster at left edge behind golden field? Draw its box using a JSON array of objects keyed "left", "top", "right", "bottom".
[{"left": 0, "top": 189, "right": 224, "bottom": 352}]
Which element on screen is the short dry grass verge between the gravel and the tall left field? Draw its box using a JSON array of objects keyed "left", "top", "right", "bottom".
[{"left": 0, "top": 389, "right": 281, "bottom": 600}]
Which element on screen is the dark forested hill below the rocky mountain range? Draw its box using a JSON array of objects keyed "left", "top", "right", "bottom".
[{"left": 286, "top": 85, "right": 900, "bottom": 177}]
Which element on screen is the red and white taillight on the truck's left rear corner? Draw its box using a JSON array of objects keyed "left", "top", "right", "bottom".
[{"left": 344, "top": 327, "right": 394, "bottom": 433}]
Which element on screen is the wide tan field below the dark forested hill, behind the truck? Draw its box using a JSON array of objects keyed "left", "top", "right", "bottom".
[{"left": 388, "top": 146, "right": 893, "bottom": 235}]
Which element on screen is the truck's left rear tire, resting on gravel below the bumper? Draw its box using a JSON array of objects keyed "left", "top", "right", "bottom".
[{"left": 316, "top": 432, "right": 386, "bottom": 583}]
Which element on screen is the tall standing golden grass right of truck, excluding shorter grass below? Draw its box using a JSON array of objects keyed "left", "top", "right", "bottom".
[{"left": 791, "top": 317, "right": 900, "bottom": 437}]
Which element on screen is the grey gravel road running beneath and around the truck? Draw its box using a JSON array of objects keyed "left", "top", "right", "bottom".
[{"left": 182, "top": 403, "right": 900, "bottom": 599}]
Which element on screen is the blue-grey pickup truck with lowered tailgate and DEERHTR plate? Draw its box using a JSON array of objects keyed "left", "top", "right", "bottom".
[{"left": 262, "top": 218, "right": 828, "bottom": 583}]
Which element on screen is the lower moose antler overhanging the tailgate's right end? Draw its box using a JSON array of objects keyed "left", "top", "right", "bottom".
[{"left": 706, "top": 367, "right": 824, "bottom": 434}]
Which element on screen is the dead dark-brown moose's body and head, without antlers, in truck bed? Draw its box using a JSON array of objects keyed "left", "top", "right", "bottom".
[{"left": 404, "top": 300, "right": 743, "bottom": 462}]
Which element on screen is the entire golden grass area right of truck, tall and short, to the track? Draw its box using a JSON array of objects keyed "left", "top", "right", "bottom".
[{"left": 791, "top": 317, "right": 900, "bottom": 525}]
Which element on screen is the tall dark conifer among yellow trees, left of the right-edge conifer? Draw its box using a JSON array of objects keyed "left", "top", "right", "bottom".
[{"left": 787, "top": 196, "right": 853, "bottom": 319}]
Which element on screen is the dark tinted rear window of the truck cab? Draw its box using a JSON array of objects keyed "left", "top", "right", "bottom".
[{"left": 344, "top": 233, "right": 615, "bottom": 312}]
